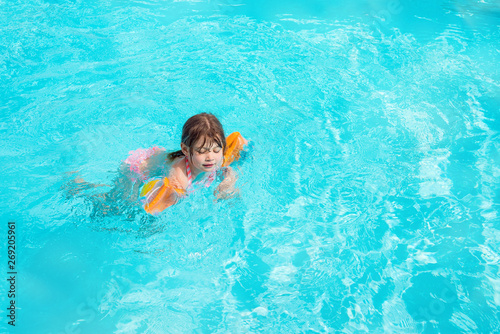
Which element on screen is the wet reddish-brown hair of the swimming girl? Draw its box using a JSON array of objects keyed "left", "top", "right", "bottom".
[{"left": 168, "top": 113, "right": 226, "bottom": 161}]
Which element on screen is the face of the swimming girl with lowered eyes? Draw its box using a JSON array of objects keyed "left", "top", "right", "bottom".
[{"left": 183, "top": 138, "right": 223, "bottom": 173}]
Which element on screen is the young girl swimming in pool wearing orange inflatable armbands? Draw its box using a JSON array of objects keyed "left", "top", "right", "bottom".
[{"left": 125, "top": 113, "right": 248, "bottom": 214}]
